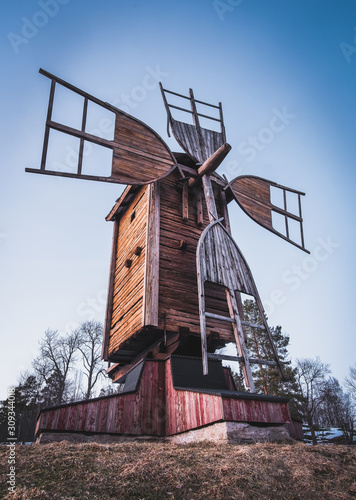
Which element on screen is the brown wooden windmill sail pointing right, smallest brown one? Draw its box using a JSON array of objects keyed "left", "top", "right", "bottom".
[{"left": 225, "top": 175, "right": 310, "bottom": 253}]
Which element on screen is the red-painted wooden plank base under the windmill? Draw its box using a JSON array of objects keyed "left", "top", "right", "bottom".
[{"left": 36, "top": 358, "right": 298, "bottom": 437}]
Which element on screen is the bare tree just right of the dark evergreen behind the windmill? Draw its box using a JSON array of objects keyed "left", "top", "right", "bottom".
[{"left": 296, "top": 357, "right": 330, "bottom": 444}]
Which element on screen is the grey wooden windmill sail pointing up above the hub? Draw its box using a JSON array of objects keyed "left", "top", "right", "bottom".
[{"left": 160, "top": 84, "right": 226, "bottom": 163}]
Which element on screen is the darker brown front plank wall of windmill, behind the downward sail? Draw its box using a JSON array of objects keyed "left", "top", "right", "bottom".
[{"left": 159, "top": 172, "right": 233, "bottom": 341}]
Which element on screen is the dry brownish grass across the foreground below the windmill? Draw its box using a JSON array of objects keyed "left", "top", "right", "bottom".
[{"left": 0, "top": 442, "right": 356, "bottom": 500}]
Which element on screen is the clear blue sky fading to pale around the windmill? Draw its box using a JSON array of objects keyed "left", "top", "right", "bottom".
[{"left": 0, "top": 0, "right": 356, "bottom": 399}]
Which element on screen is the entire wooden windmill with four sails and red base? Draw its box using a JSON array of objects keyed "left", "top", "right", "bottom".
[{"left": 27, "top": 70, "right": 305, "bottom": 438}]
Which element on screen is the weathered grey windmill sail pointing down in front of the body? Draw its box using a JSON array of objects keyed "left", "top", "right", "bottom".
[{"left": 196, "top": 219, "right": 283, "bottom": 392}]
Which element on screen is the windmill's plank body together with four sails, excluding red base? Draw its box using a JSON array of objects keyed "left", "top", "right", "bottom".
[{"left": 30, "top": 70, "right": 306, "bottom": 442}]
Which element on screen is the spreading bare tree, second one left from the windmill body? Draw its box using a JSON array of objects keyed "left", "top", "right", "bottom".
[{"left": 32, "top": 329, "right": 78, "bottom": 404}]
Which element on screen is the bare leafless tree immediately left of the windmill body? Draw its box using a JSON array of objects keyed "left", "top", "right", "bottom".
[{"left": 76, "top": 321, "right": 105, "bottom": 399}]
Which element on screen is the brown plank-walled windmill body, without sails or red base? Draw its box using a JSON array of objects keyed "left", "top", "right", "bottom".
[{"left": 103, "top": 156, "right": 234, "bottom": 379}]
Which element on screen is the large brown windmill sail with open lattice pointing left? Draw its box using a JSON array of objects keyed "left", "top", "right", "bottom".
[{"left": 26, "top": 69, "right": 176, "bottom": 184}]
